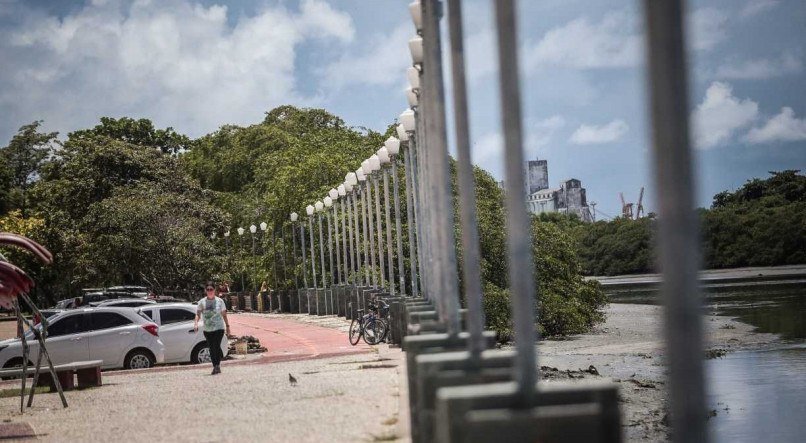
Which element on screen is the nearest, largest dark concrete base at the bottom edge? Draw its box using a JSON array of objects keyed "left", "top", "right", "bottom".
[{"left": 436, "top": 381, "right": 622, "bottom": 443}]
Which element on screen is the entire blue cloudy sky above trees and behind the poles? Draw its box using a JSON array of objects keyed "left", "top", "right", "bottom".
[{"left": 0, "top": 0, "right": 806, "bottom": 218}]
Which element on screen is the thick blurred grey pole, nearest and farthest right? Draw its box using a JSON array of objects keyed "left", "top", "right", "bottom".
[{"left": 644, "top": 0, "right": 707, "bottom": 442}]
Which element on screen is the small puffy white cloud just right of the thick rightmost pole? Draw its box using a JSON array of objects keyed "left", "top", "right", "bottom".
[{"left": 692, "top": 82, "right": 758, "bottom": 149}]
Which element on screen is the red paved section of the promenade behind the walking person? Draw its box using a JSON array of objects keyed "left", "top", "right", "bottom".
[{"left": 227, "top": 314, "right": 372, "bottom": 363}]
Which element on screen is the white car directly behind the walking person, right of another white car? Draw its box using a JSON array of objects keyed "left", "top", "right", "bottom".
[{"left": 139, "top": 303, "right": 229, "bottom": 363}]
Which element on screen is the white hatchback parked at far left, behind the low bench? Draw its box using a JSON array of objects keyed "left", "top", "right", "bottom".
[{"left": 0, "top": 308, "right": 165, "bottom": 369}]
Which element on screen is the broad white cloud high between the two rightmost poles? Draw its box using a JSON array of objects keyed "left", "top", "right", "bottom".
[{"left": 524, "top": 12, "right": 641, "bottom": 70}]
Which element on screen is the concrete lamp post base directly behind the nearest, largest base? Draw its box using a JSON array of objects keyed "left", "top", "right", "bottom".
[{"left": 410, "top": 350, "right": 516, "bottom": 442}]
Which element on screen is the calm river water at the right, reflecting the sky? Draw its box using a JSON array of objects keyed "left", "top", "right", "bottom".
[{"left": 612, "top": 282, "right": 806, "bottom": 443}]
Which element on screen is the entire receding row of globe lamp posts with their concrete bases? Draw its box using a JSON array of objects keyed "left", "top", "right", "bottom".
[{"left": 287, "top": 0, "right": 707, "bottom": 442}]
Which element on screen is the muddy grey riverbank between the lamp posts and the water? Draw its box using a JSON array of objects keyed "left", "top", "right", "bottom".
[{"left": 524, "top": 304, "right": 779, "bottom": 441}]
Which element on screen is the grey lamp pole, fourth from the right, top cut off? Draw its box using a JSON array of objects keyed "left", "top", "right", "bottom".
[{"left": 423, "top": 0, "right": 460, "bottom": 334}]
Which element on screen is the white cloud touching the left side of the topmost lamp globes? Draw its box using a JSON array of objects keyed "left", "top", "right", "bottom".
[{"left": 319, "top": 22, "right": 413, "bottom": 89}]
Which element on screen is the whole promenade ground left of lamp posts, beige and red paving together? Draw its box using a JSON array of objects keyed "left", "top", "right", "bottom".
[{"left": 0, "top": 314, "right": 407, "bottom": 442}]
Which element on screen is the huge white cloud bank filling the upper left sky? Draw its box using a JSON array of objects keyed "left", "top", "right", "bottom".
[{"left": 0, "top": 0, "right": 354, "bottom": 136}]
